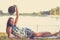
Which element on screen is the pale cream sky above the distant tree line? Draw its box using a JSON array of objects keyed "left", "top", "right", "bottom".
[{"left": 0, "top": 0, "right": 60, "bottom": 13}]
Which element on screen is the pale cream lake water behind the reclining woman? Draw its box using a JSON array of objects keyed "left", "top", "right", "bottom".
[{"left": 0, "top": 16, "right": 60, "bottom": 33}]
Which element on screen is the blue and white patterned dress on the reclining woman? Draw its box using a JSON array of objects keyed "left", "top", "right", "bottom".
[{"left": 13, "top": 27, "right": 33, "bottom": 37}]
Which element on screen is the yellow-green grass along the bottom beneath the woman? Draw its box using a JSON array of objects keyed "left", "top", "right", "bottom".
[{"left": 0, "top": 33, "right": 60, "bottom": 40}]
